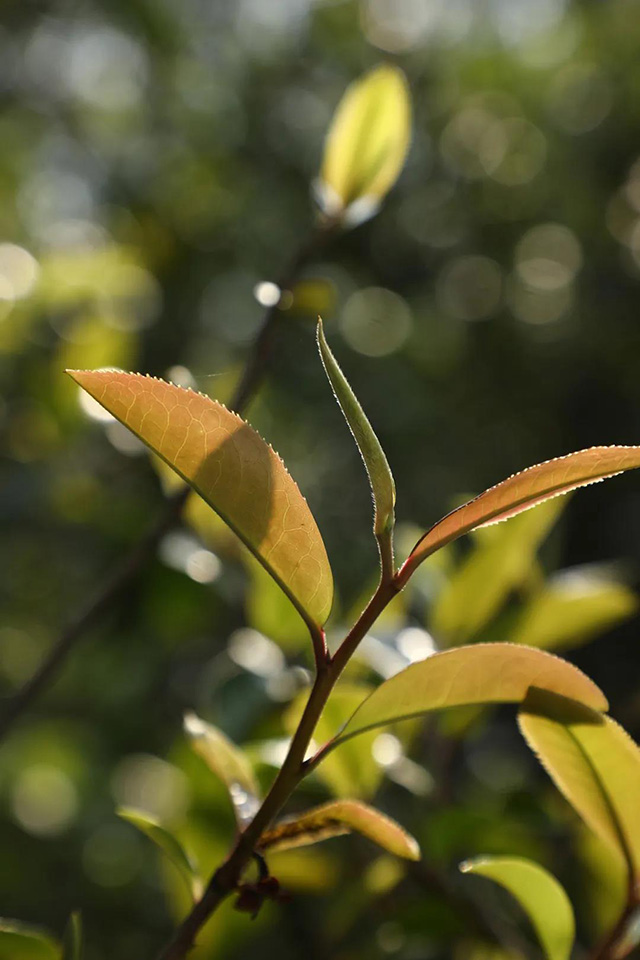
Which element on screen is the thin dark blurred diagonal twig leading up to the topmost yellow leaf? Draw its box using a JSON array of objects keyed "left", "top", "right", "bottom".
[{"left": 0, "top": 221, "right": 334, "bottom": 742}]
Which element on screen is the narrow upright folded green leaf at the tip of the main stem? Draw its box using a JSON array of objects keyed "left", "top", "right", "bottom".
[{"left": 318, "top": 317, "right": 396, "bottom": 537}]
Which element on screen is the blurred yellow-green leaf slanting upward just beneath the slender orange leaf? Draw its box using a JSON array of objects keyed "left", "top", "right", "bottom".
[{"left": 430, "top": 499, "right": 563, "bottom": 647}]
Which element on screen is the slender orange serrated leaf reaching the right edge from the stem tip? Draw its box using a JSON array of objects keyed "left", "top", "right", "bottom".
[{"left": 401, "top": 446, "right": 640, "bottom": 582}]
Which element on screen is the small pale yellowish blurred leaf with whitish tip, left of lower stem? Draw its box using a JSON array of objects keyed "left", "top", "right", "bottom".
[{"left": 184, "top": 713, "right": 259, "bottom": 823}]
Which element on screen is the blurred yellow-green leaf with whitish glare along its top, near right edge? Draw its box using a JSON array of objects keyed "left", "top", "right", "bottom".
[{"left": 509, "top": 569, "right": 638, "bottom": 650}]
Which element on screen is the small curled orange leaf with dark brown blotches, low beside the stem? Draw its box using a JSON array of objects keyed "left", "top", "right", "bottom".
[{"left": 259, "top": 800, "right": 420, "bottom": 860}]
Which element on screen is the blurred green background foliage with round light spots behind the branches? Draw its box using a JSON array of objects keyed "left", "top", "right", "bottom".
[{"left": 0, "top": 0, "right": 640, "bottom": 960}]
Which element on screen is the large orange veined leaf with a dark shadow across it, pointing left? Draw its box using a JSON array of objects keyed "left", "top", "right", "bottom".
[{"left": 68, "top": 370, "right": 333, "bottom": 628}]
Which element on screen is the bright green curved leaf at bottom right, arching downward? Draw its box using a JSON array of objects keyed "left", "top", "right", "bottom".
[{"left": 460, "top": 857, "right": 575, "bottom": 960}]
